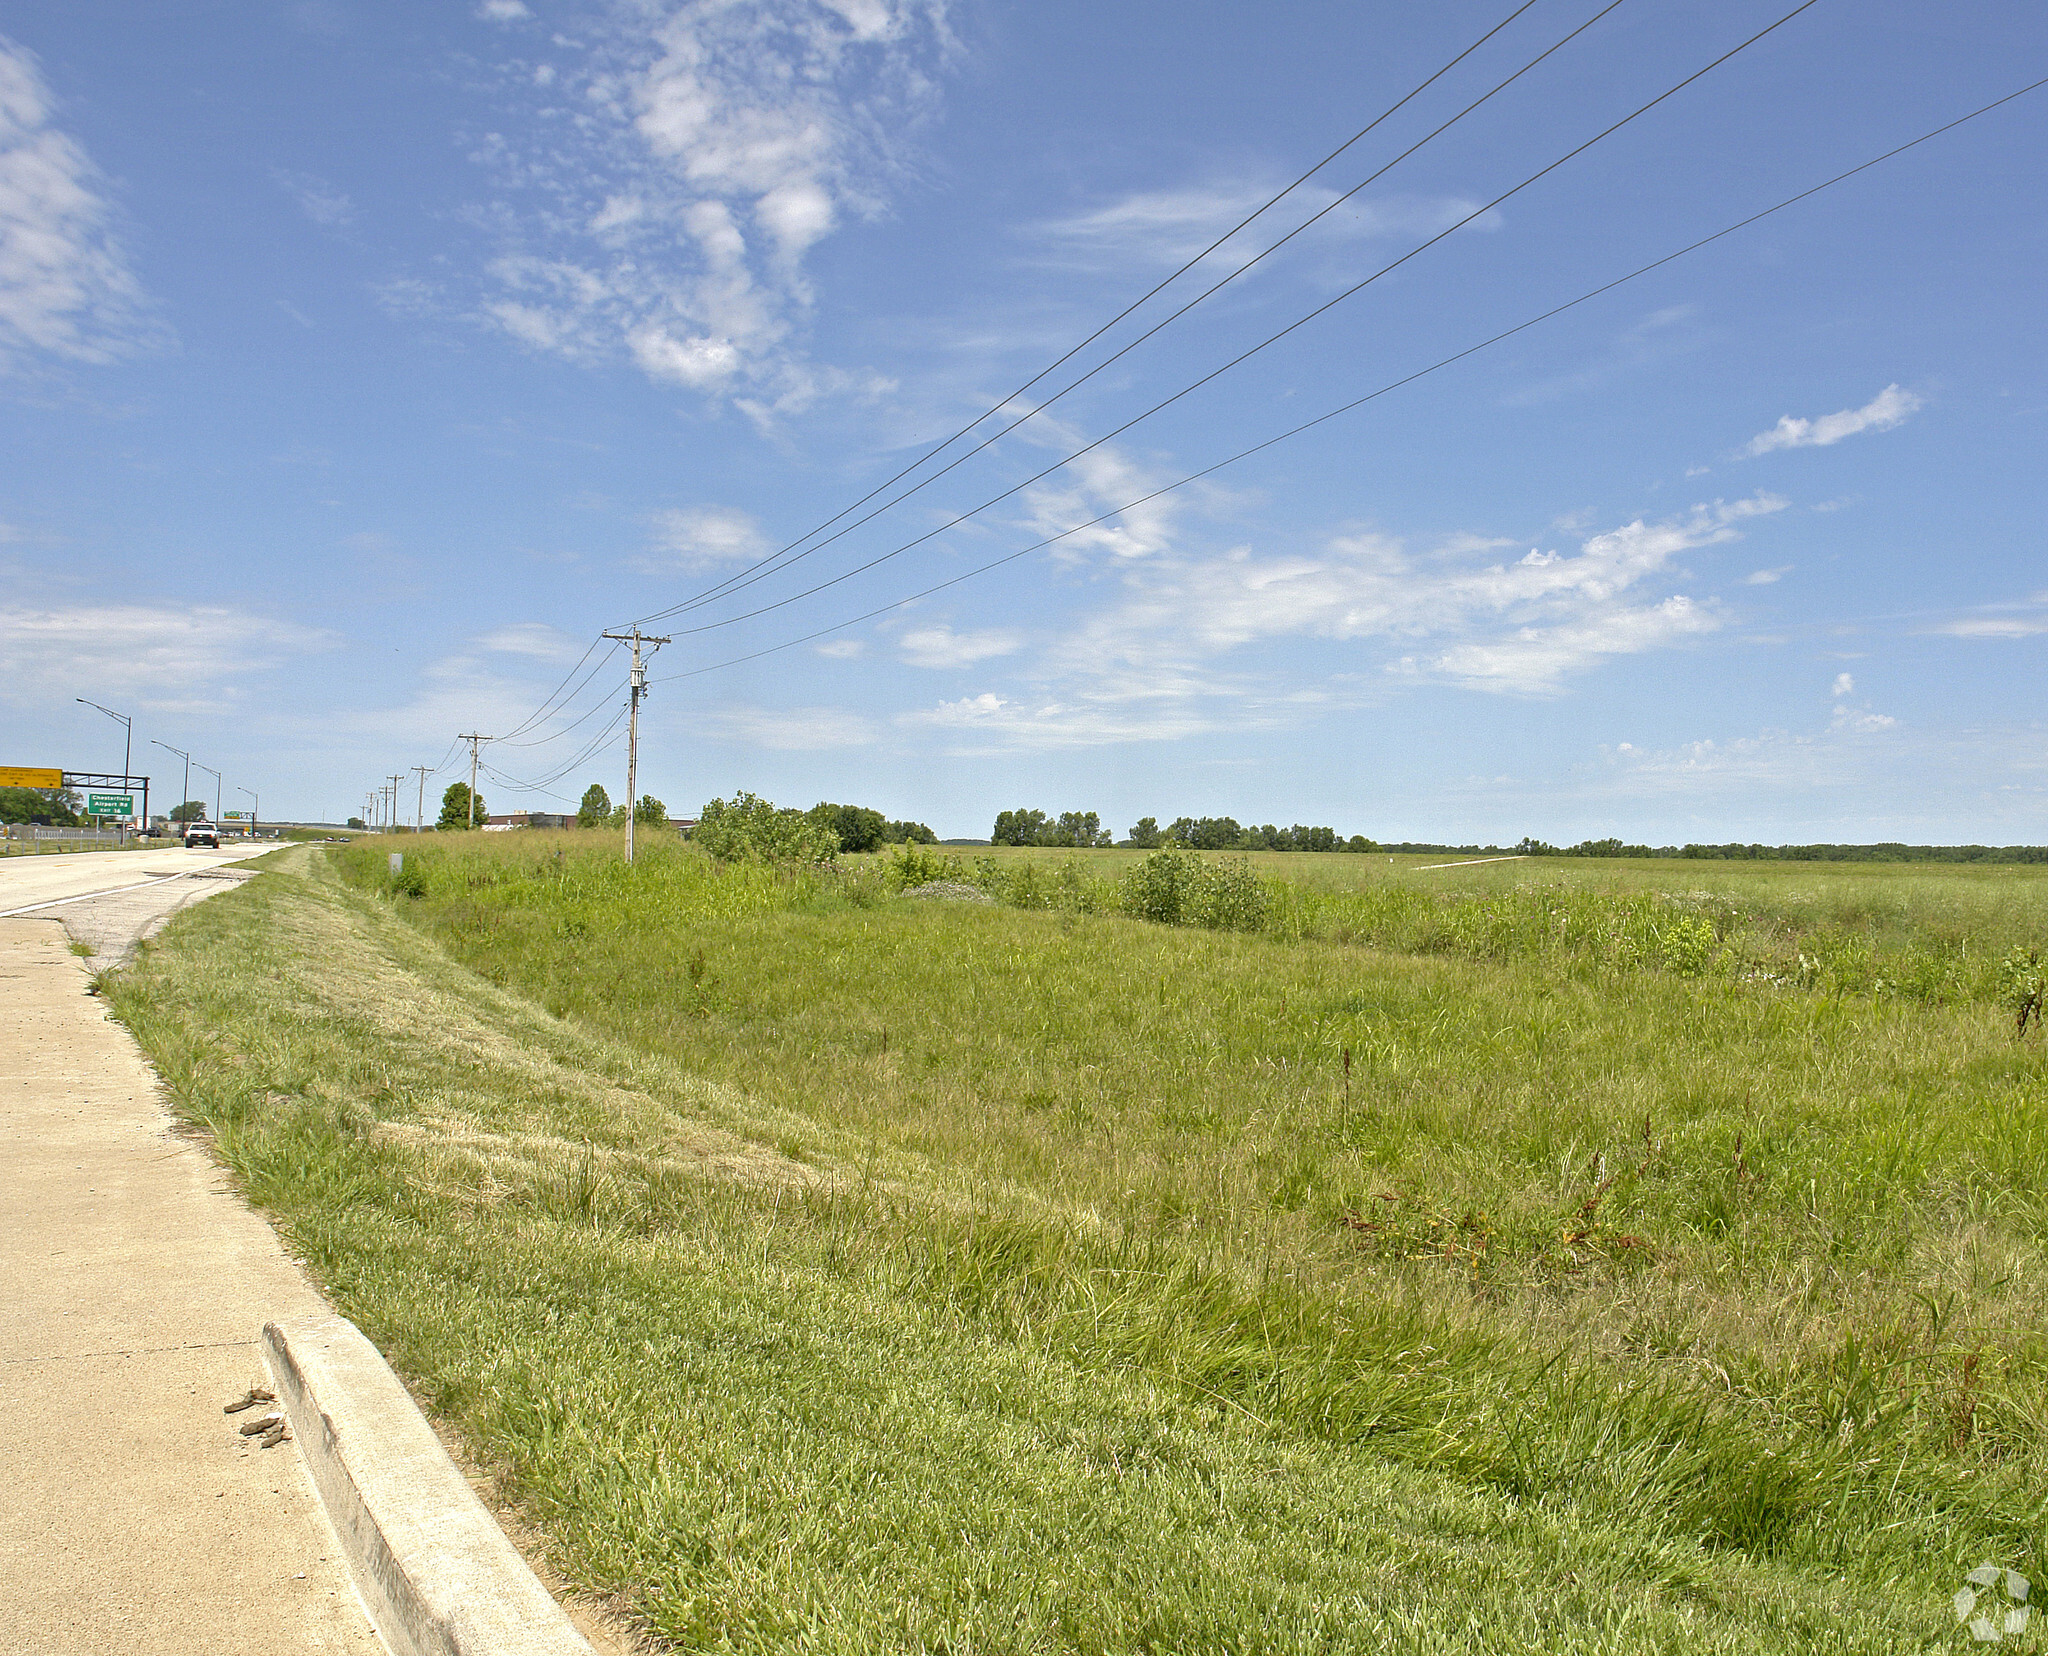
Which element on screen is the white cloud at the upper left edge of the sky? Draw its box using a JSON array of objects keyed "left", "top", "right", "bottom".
[{"left": 0, "top": 39, "right": 158, "bottom": 366}]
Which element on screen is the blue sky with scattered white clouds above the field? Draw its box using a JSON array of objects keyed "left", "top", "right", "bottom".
[{"left": 0, "top": 0, "right": 2048, "bottom": 843}]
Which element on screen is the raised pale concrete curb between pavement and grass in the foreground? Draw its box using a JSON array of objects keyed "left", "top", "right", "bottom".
[{"left": 262, "top": 1316, "right": 594, "bottom": 1656}]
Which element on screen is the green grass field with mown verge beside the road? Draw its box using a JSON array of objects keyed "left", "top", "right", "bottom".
[{"left": 109, "top": 833, "right": 2048, "bottom": 1652}]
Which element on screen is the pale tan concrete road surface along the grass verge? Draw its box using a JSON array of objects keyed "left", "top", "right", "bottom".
[{"left": 0, "top": 847, "right": 383, "bottom": 1656}]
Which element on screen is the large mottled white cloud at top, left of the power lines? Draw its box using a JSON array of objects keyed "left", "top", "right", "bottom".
[{"left": 475, "top": 0, "right": 952, "bottom": 409}]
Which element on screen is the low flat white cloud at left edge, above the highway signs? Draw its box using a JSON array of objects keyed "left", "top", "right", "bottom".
[{"left": 0, "top": 604, "right": 340, "bottom": 706}]
